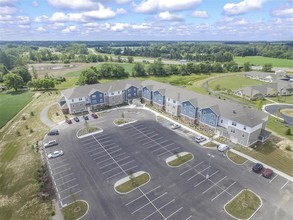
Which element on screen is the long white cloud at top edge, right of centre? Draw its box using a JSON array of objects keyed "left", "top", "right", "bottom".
[{"left": 133, "top": 0, "right": 202, "bottom": 13}]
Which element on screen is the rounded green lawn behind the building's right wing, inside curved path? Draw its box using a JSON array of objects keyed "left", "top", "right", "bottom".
[{"left": 209, "top": 75, "right": 261, "bottom": 90}]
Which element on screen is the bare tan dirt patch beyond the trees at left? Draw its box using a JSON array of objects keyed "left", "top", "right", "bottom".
[{"left": 28, "top": 63, "right": 97, "bottom": 78}]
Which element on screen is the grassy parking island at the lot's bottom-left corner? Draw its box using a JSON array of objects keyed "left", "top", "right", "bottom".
[{"left": 62, "top": 200, "right": 89, "bottom": 220}]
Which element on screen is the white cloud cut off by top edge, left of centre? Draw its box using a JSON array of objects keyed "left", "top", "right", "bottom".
[{"left": 48, "top": 0, "right": 99, "bottom": 10}]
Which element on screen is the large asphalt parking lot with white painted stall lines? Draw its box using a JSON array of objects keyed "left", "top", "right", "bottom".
[{"left": 42, "top": 110, "right": 293, "bottom": 220}]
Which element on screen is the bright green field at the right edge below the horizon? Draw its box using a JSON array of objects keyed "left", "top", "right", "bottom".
[{"left": 234, "top": 56, "right": 293, "bottom": 68}]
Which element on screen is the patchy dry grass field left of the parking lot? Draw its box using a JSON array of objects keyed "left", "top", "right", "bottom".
[{"left": 0, "top": 92, "right": 60, "bottom": 220}]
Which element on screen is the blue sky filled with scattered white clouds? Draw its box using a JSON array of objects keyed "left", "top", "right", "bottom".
[{"left": 0, "top": 0, "right": 293, "bottom": 41}]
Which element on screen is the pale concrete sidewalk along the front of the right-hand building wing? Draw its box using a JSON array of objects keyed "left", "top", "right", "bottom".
[{"left": 140, "top": 106, "right": 293, "bottom": 182}]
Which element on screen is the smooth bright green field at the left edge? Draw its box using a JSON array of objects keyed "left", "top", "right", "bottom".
[{"left": 0, "top": 92, "right": 33, "bottom": 128}]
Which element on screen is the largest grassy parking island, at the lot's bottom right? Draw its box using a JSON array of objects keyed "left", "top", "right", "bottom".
[{"left": 224, "top": 189, "right": 262, "bottom": 219}]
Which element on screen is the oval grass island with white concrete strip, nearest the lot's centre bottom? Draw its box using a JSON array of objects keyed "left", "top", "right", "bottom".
[{"left": 114, "top": 171, "right": 151, "bottom": 194}]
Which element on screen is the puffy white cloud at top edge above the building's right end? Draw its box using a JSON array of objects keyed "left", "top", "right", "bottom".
[{"left": 224, "top": 0, "right": 267, "bottom": 15}]
